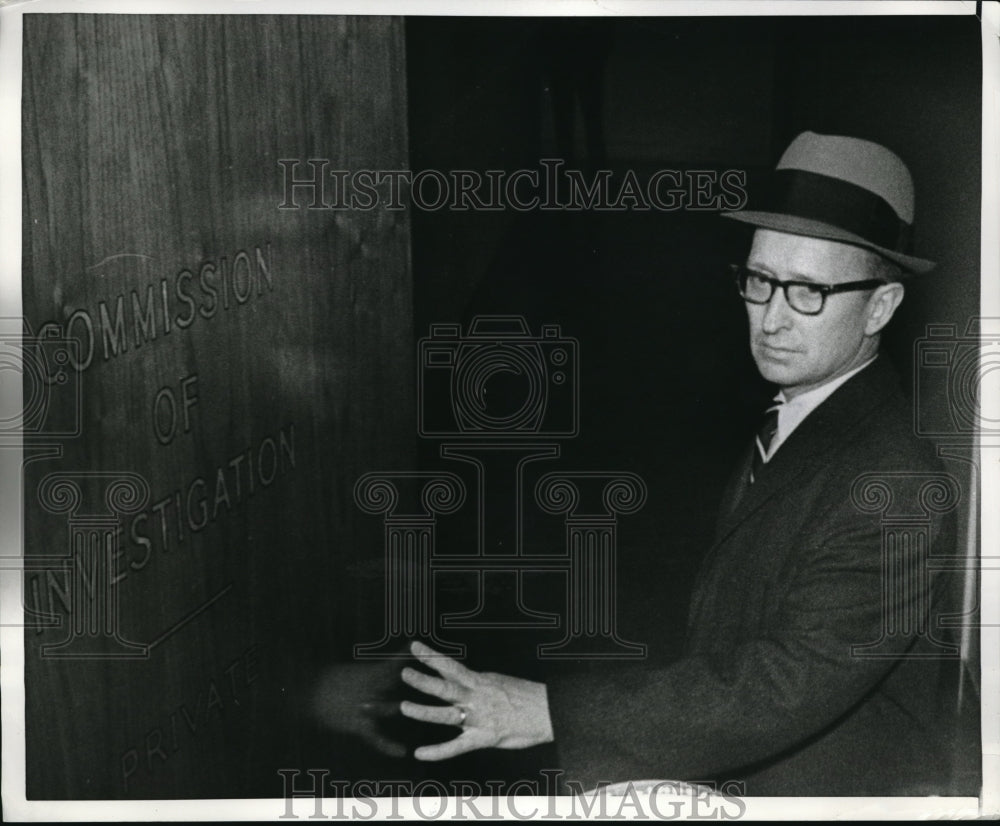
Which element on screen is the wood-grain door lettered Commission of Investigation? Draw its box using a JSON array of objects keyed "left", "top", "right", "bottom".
[{"left": 23, "top": 14, "right": 414, "bottom": 798}]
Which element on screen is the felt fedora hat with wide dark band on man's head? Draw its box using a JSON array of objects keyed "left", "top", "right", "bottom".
[{"left": 723, "top": 132, "right": 935, "bottom": 273}]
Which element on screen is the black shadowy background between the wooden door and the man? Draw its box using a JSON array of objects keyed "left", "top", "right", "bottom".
[{"left": 407, "top": 9, "right": 981, "bottom": 792}]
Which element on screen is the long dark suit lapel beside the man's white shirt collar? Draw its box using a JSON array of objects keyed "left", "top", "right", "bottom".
[{"left": 716, "top": 355, "right": 899, "bottom": 543}]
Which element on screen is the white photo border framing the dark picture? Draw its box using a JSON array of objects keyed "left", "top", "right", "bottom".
[{"left": 0, "top": 0, "right": 1000, "bottom": 821}]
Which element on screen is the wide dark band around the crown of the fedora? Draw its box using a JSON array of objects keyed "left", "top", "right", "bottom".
[{"left": 763, "top": 169, "right": 913, "bottom": 253}]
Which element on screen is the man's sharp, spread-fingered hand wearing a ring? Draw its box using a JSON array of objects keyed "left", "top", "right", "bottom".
[{"left": 399, "top": 642, "right": 553, "bottom": 760}]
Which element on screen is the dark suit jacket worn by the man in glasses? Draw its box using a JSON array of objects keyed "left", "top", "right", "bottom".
[{"left": 549, "top": 356, "right": 957, "bottom": 795}]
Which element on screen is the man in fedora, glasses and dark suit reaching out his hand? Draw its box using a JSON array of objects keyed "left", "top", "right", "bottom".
[{"left": 401, "top": 132, "right": 957, "bottom": 795}]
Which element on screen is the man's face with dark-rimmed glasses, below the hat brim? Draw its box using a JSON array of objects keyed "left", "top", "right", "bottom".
[{"left": 746, "top": 229, "right": 891, "bottom": 397}]
